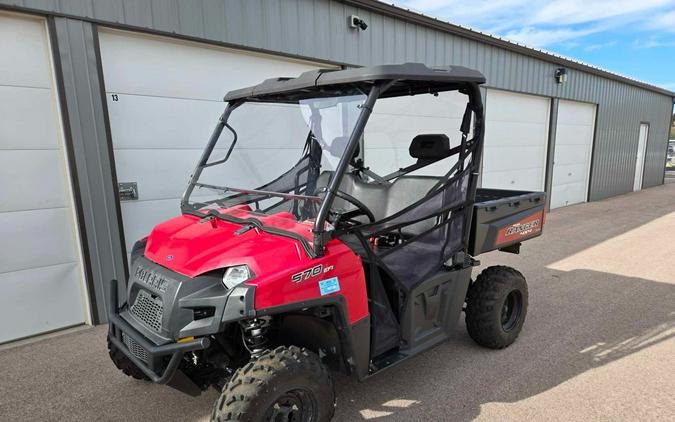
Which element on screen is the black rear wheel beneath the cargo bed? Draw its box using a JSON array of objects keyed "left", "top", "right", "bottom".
[{"left": 466, "top": 266, "right": 528, "bottom": 349}]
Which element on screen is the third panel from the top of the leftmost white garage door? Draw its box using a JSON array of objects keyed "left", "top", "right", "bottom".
[{"left": 0, "top": 150, "right": 68, "bottom": 212}]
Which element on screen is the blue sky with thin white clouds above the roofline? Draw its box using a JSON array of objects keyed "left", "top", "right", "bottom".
[{"left": 394, "top": 0, "right": 675, "bottom": 91}]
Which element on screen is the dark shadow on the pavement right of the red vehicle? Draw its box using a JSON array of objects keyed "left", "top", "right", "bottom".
[{"left": 336, "top": 271, "right": 675, "bottom": 421}]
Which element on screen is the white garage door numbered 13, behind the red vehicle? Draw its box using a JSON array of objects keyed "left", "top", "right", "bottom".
[{"left": 100, "top": 30, "right": 326, "bottom": 258}]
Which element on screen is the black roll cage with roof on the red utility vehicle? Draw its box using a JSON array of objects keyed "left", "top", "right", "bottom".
[{"left": 181, "top": 63, "right": 485, "bottom": 261}]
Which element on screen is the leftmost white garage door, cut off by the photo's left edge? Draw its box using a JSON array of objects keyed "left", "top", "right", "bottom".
[{"left": 0, "top": 14, "right": 85, "bottom": 343}]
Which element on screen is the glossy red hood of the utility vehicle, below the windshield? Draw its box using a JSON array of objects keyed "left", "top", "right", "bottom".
[{"left": 145, "top": 210, "right": 312, "bottom": 277}]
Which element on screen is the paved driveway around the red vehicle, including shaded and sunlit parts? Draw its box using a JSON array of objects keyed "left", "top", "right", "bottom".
[{"left": 0, "top": 184, "right": 675, "bottom": 421}]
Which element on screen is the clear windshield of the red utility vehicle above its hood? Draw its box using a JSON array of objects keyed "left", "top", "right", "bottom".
[{"left": 184, "top": 93, "right": 366, "bottom": 221}]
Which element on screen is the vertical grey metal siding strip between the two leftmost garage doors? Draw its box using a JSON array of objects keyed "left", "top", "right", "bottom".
[{"left": 51, "top": 18, "right": 125, "bottom": 322}]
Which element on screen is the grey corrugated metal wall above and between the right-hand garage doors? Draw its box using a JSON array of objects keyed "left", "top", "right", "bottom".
[{"left": 0, "top": 0, "right": 672, "bottom": 200}]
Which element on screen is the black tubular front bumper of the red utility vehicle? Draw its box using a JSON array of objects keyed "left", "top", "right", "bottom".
[{"left": 108, "top": 280, "right": 211, "bottom": 384}]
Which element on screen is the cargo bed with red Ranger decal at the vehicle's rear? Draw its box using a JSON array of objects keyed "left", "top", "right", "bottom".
[{"left": 469, "top": 189, "right": 546, "bottom": 256}]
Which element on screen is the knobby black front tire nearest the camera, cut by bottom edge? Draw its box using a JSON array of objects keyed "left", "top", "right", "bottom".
[{"left": 211, "top": 346, "right": 335, "bottom": 422}]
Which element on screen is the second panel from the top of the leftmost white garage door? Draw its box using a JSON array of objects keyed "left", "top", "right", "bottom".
[{"left": 0, "top": 85, "right": 59, "bottom": 150}]
